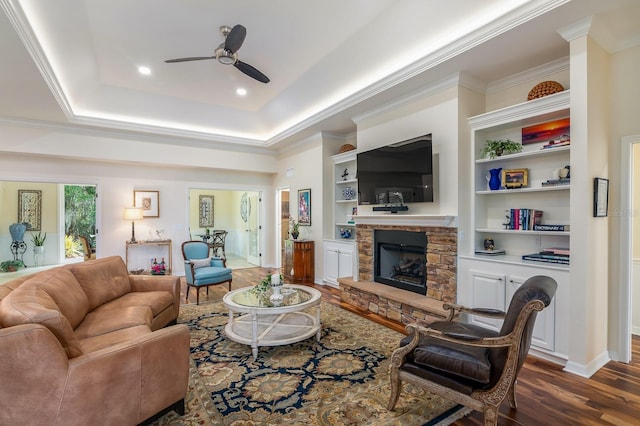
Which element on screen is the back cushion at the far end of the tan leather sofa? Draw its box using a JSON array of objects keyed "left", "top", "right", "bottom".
[{"left": 69, "top": 256, "right": 131, "bottom": 310}]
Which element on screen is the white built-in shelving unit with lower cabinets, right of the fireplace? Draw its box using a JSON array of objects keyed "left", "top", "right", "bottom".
[{"left": 458, "top": 90, "right": 568, "bottom": 364}]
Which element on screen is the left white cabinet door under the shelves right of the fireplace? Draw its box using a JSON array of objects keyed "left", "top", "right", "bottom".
[{"left": 469, "top": 271, "right": 505, "bottom": 331}]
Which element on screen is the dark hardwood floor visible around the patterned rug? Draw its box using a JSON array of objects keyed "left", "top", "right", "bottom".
[{"left": 182, "top": 268, "right": 640, "bottom": 426}]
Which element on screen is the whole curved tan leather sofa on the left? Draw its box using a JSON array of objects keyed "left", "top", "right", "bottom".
[{"left": 0, "top": 256, "right": 189, "bottom": 425}]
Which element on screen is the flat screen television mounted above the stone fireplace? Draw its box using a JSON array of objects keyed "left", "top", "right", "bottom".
[{"left": 357, "top": 134, "right": 433, "bottom": 211}]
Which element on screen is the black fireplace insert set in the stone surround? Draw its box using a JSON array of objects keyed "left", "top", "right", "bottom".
[{"left": 373, "top": 230, "right": 427, "bottom": 295}]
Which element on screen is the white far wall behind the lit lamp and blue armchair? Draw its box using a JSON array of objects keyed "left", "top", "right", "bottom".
[{"left": 0, "top": 154, "right": 273, "bottom": 275}]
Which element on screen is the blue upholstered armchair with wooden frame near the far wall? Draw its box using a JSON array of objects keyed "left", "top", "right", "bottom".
[{"left": 182, "top": 241, "right": 232, "bottom": 305}]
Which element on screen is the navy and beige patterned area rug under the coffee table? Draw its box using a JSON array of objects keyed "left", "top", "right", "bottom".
[{"left": 150, "top": 302, "right": 469, "bottom": 426}]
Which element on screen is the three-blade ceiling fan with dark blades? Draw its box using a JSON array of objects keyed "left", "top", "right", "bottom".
[{"left": 165, "top": 24, "right": 270, "bottom": 83}]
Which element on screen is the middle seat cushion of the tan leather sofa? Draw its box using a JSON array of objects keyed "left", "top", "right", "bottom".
[{"left": 74, "top": 306, "right": 152, "bottom": 340}]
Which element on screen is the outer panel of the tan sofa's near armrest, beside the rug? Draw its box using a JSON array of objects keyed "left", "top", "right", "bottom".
[{"left": 66, "top": 324, "right": 190, "bottom": 424}]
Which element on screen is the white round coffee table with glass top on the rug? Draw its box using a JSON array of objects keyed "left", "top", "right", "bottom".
[{"left": 222, "top": 285, "right": 321, "bottom": 359}]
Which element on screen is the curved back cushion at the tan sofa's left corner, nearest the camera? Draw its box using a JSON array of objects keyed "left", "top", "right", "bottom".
[{"left": 0, "top": 268, "right": 89, "bottom": 358}]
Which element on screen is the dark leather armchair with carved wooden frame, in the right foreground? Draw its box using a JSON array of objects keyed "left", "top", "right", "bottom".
[{"left": 387, "top": 275, "right": 557, "bottom": 425}]
